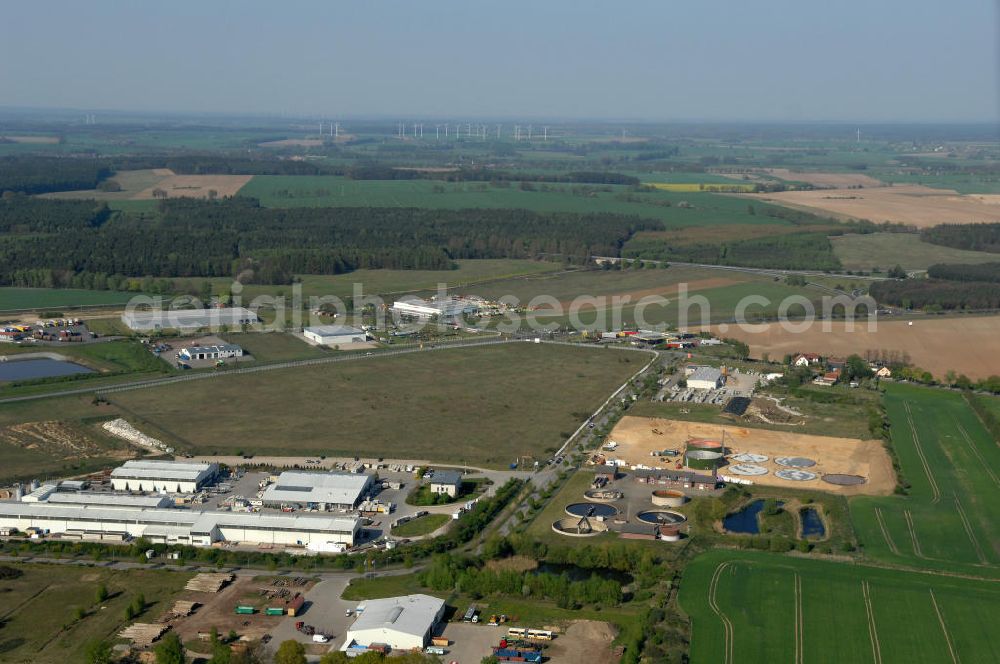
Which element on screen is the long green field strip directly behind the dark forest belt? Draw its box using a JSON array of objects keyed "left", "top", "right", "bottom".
[{"left": 239, "top": 175, "right": 788, "bottom": 227}]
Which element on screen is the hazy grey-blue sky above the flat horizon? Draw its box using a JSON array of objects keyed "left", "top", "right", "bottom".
[{"left": 0, "top": 0, "right": 1000, "bottom": 122}]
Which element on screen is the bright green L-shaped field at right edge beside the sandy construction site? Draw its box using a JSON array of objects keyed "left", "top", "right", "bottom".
[{"left": 851, "top": 385, "right": 1000, "bottom": 577}]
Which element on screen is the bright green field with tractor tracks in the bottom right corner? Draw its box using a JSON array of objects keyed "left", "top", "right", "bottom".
[{"left": 679, "top": 550, "right": 1000, "bottom": 664}]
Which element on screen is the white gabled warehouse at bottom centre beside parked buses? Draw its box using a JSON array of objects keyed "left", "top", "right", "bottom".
[{"left": 341, "top": 595, "right": 445, "bottom": 653}]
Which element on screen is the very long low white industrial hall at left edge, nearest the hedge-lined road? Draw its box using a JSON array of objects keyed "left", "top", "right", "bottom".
[{"left": 0, "top": 494, "right": 361, "bottom": 552}]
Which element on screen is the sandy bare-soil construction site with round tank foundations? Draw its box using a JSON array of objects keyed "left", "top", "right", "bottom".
[{"left": 609, "top": 416, "right": 896, "bottom": 496}]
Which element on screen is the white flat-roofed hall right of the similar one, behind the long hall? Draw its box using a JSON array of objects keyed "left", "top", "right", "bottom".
[{"left": 261, "top": 470, "right": 374, "bottom": 510}]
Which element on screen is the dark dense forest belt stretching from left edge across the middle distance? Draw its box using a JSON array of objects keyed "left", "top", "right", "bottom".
[{"left": 0, "top": 195, "right": 660, "bottom": 288}]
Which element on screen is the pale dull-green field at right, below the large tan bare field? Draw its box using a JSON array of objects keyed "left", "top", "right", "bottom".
[{"left": 830, "top": 233, "right": 1000, "bottom": 272}]
